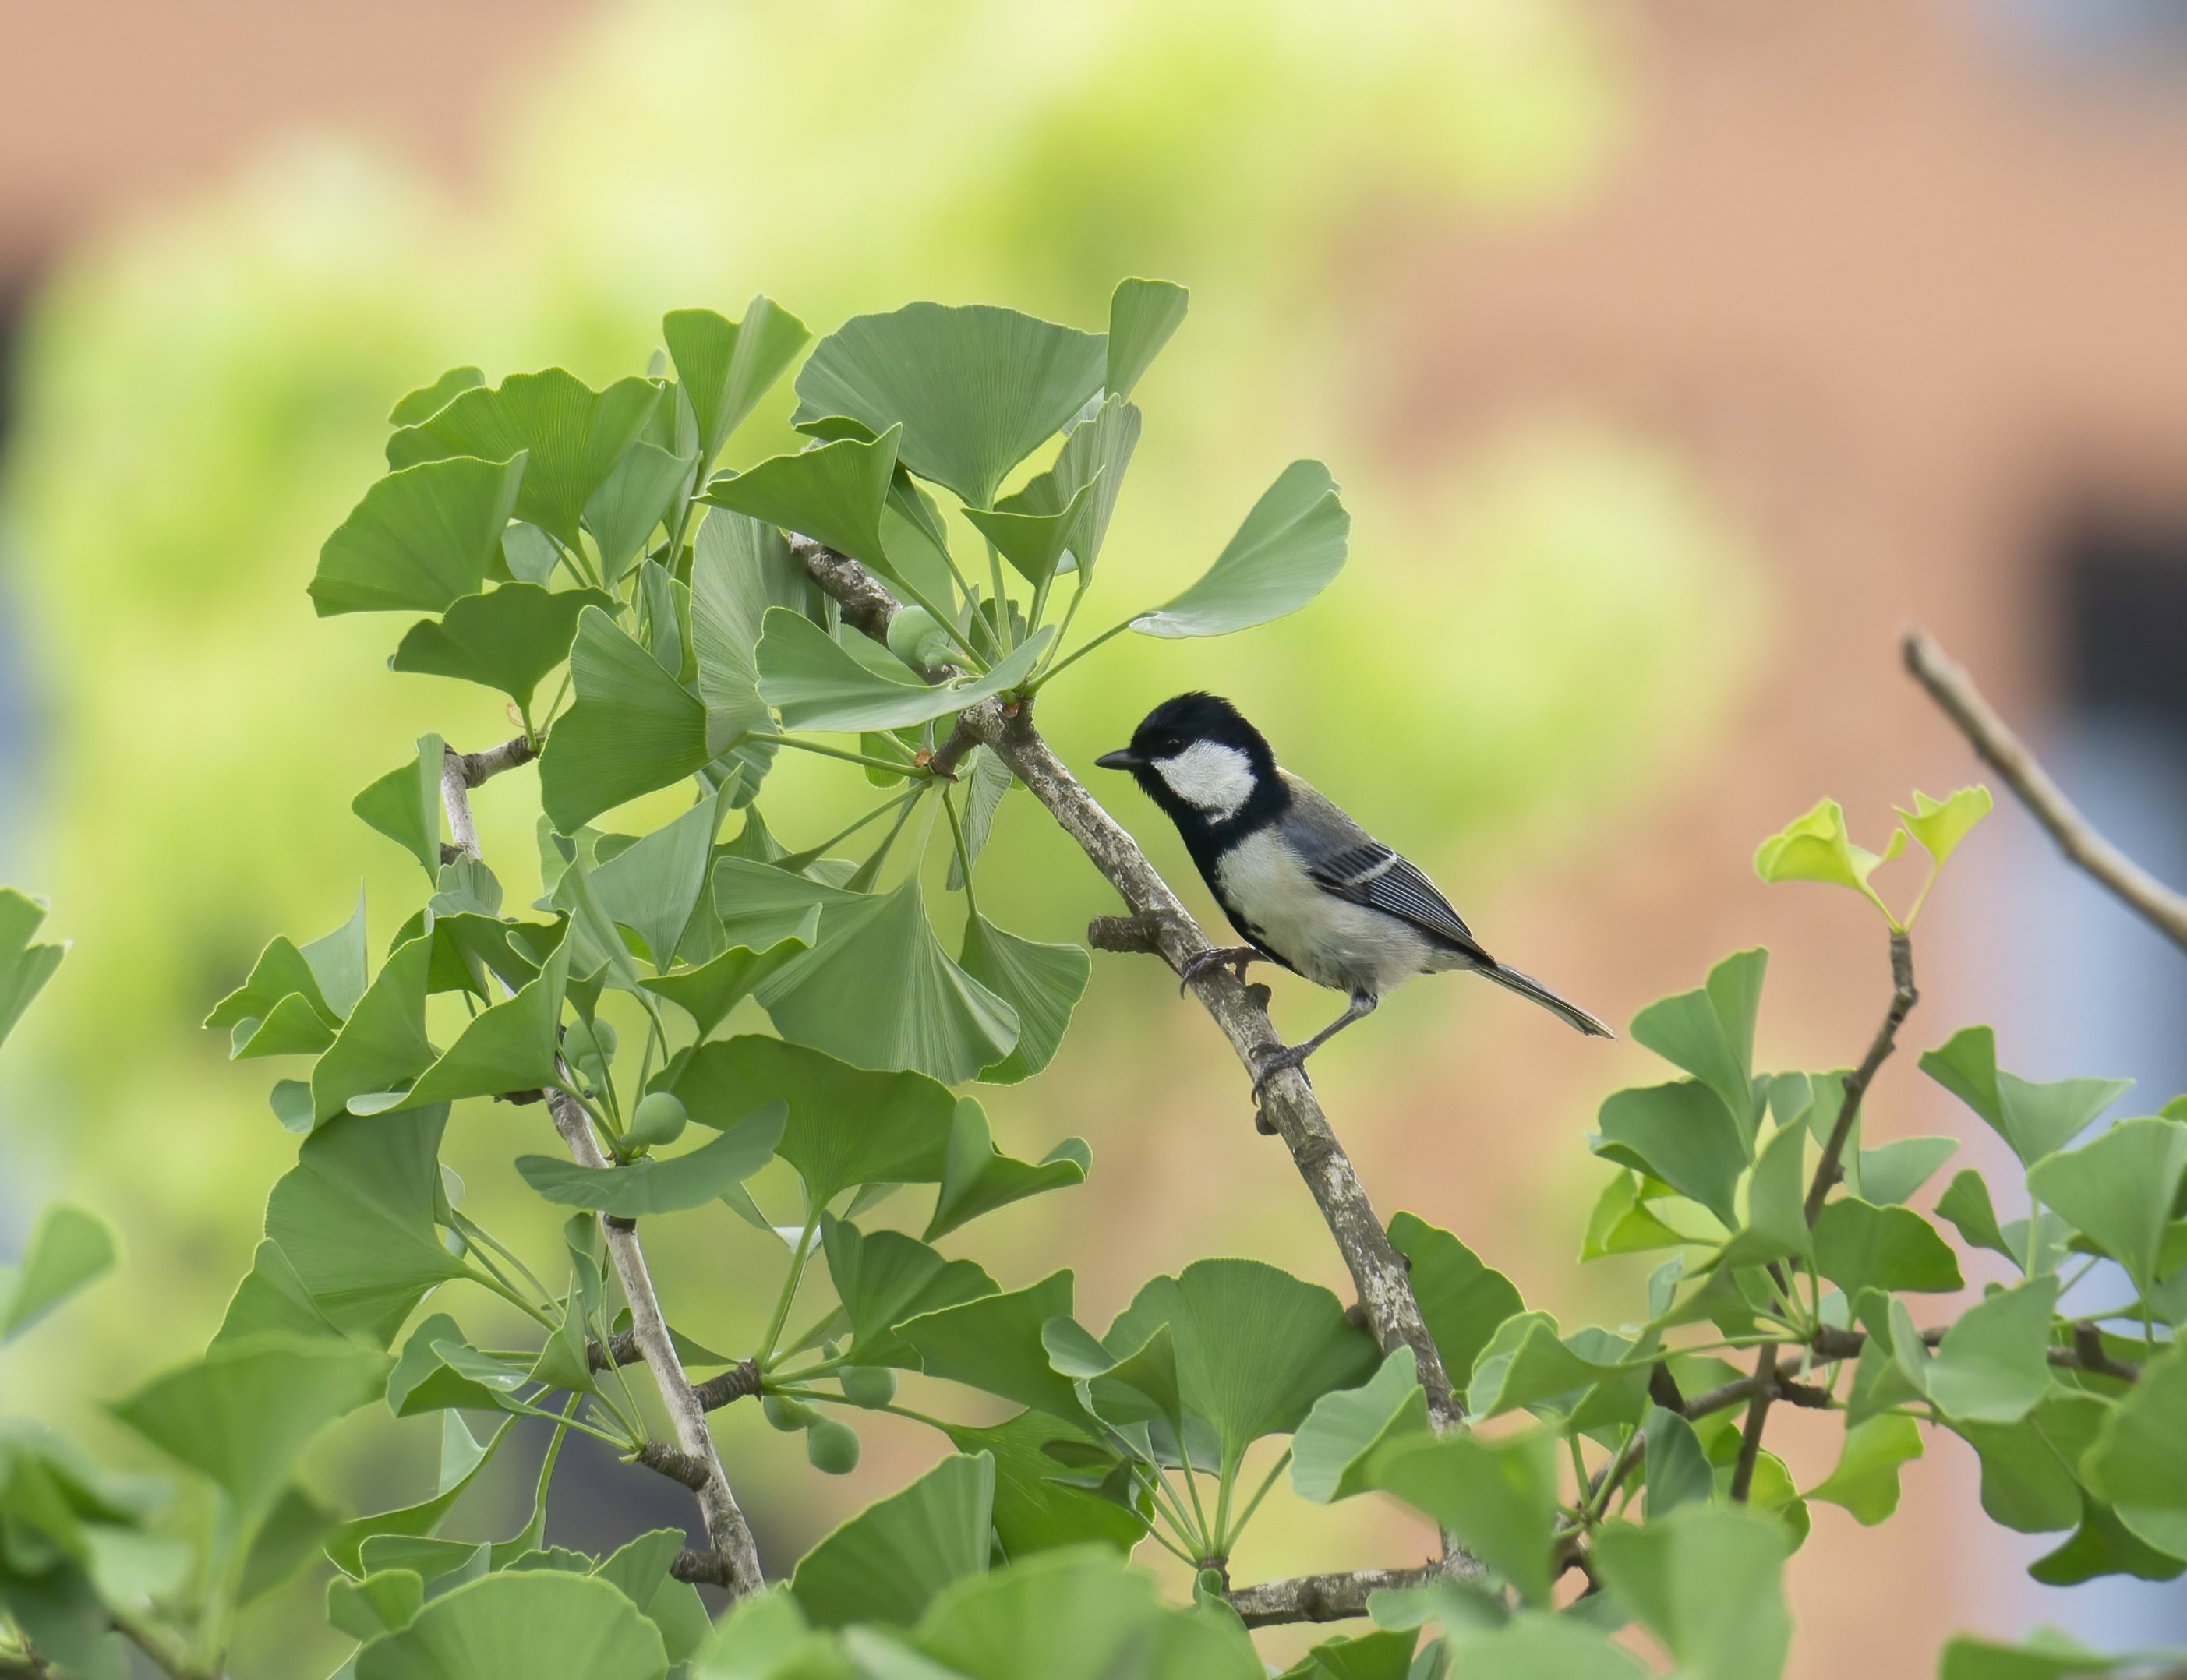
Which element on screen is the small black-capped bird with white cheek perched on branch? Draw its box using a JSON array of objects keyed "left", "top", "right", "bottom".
[{"left": 1096, "top": 694, "right": 1616, "bottom": 1100}]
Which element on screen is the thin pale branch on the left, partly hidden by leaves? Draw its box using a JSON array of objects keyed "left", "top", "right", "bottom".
[{"left": 442, "top": 742, "right": 765, "bottom": 1595}]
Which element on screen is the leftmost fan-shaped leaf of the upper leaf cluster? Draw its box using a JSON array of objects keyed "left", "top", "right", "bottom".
[{"left": 310, "top": 454, "right": 527, "bottom": 619}]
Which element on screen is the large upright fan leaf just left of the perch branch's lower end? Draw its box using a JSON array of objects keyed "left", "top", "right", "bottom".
[{"left": 1102, "top": 1260, "right": 1380, "bottom": 1463}]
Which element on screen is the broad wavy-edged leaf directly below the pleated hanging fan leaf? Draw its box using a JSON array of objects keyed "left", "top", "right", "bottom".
[{"left": 667, "top": 1037, "right": 956, "bottom": 1209}]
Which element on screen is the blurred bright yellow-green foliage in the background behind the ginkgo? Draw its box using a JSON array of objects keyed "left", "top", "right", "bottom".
[{"left": 0, "top": 0, "right": 1765, "bottom": 1674}]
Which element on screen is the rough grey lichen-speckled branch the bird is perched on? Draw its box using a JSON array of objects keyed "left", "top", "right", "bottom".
[{"left": 792, "top": 538, "right": 1461, "bottom": 1428}]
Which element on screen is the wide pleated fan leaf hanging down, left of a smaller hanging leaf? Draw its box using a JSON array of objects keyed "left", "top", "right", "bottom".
[{"left": 757, "top": 875, "right": 1019, "bottom": 1085}]
